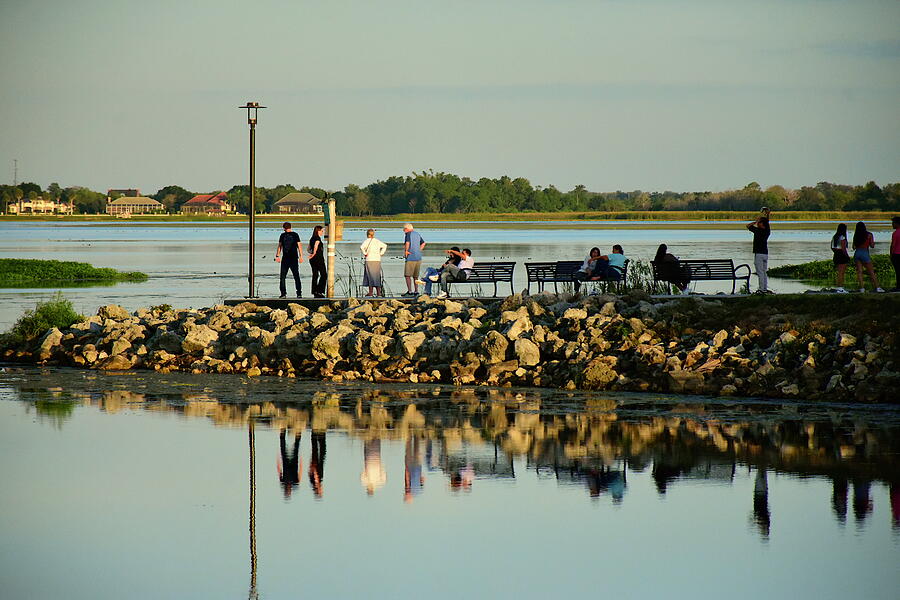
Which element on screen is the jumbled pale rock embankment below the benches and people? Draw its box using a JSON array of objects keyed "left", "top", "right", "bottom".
[{"left": 0, "top": 293, "right": 900, "bottom": 402}]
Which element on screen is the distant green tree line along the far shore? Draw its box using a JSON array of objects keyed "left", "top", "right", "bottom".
[{"left": 0, "top": 171, "right": 900, "bottom": 216}]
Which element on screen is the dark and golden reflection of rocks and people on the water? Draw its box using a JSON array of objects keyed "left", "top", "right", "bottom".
[{"left": 0, "top": 369, "right": 900, "bottom": 544}]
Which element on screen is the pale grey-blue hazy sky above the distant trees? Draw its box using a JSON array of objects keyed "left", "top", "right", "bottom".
[{"left": 0, "top": 0, "right": 900, "bottom": 194}]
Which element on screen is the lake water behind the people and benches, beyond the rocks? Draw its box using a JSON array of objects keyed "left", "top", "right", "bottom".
[{"left": 0, "top": 221, "right": 889, "bottom": 330}]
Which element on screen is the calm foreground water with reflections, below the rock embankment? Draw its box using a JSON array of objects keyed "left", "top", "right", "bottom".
[{"left": 0, "top": 368, "right": 900, "bottom": 599}]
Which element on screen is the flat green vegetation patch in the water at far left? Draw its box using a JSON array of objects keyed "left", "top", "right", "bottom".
[{"left": 0, "top": 258, "right": 147, "bottom": 287}]
